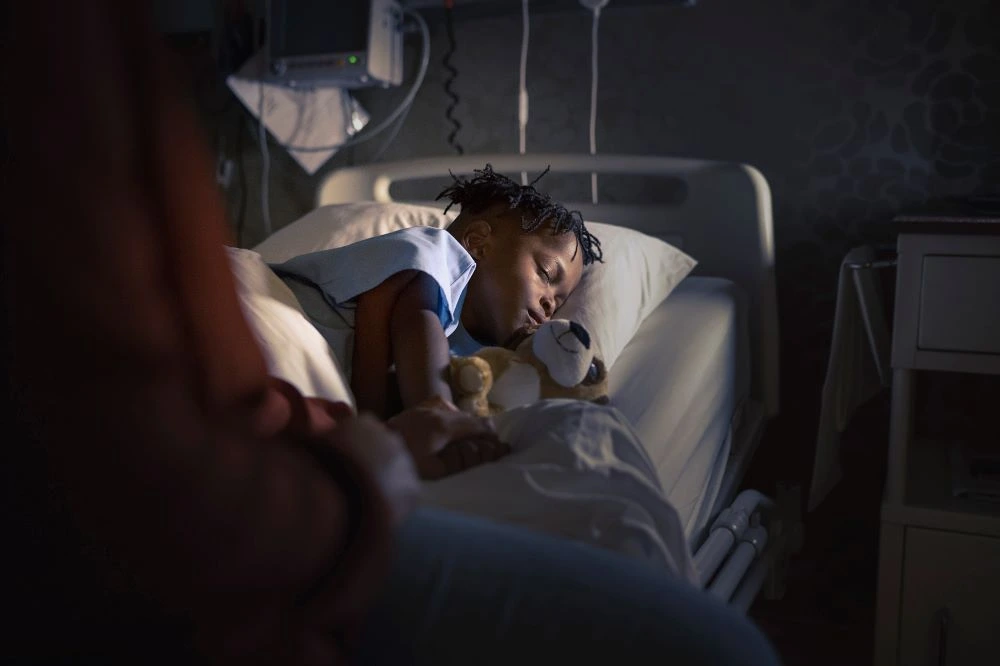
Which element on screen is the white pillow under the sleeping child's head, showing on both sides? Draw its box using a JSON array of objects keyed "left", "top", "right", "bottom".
[{"left": 254, "top": 202, "right": 697, "bottom": 368}]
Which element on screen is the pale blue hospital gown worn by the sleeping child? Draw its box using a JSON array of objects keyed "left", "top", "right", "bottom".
[{"left": 271, "top": 227, "right": 478, "bottom": 377}]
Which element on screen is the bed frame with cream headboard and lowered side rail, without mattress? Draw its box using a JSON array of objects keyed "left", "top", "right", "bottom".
[{"left": 316, "top": 154, "right": 798, "bottom": 610}]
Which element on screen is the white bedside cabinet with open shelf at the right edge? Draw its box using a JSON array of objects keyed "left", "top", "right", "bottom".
[{"left": 875, "top": 209, "right": 1000, "bottom": 666}]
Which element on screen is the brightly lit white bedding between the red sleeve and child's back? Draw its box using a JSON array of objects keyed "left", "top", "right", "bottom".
[{"left": 226, "top": 247, "right": 354, "bottom": 406}]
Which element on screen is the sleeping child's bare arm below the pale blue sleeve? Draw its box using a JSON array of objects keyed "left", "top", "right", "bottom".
[{"left": 351, "top": 270, "right": 452, "bottom": 416}]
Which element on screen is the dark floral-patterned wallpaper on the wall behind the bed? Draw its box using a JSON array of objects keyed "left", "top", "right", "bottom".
[{"left": 229, "top": 0, "right": 1000, "bottom": 456}]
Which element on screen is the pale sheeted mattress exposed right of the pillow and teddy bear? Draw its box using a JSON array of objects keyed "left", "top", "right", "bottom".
[{"left": 609, "top": 276, "right": 750, "bottom": 538}]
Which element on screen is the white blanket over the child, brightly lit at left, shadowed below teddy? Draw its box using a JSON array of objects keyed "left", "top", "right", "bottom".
[{"left": 229, "top": 248, "right": 696, "bottom": 582}]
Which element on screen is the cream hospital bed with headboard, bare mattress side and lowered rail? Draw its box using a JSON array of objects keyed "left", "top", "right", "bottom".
[{"left": 262, "top": 154, "right": 794, "bottom": 609}]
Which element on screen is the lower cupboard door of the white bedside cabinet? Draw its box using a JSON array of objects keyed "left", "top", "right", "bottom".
[{"left": 899, "top": 527, "right": 1000, "bottom": 666}]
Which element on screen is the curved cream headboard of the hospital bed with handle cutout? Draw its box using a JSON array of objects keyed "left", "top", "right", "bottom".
[{"left": 316, "top": 153, "right": 778, "bottom": 416}]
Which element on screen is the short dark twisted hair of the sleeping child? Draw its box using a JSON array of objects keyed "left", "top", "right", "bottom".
[{"left": 437, "top": 164, "right": 603, "bottom": 266}]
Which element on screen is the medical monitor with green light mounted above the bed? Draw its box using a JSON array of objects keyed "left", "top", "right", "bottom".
[{"left": 267, "top": 0, "right": 403, "bottom": 88}]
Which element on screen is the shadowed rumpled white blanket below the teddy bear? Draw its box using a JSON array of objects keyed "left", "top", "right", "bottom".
[{"left": 424, "top": 400, "right": 696, "bottom": 582}]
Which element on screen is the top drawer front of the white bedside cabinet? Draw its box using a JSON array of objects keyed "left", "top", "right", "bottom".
[{"left": 917, "top": 255, "right": 1000, "bottom": 354}]
